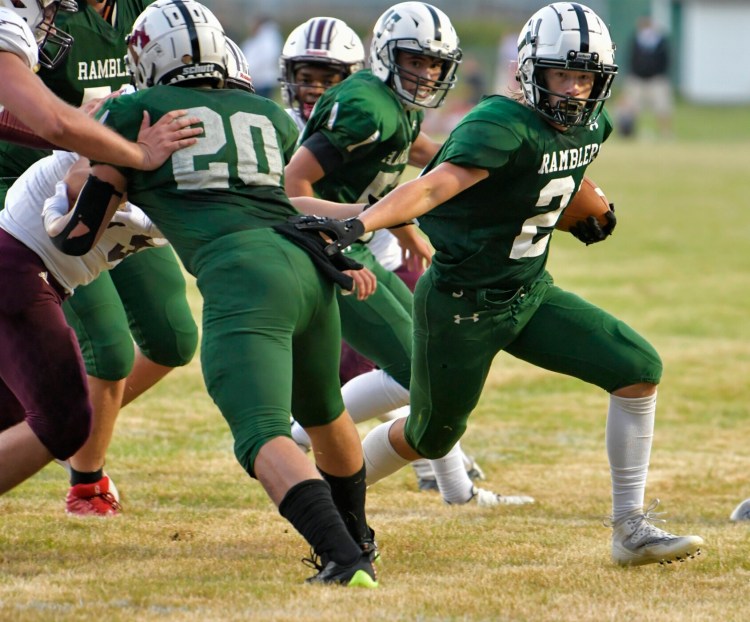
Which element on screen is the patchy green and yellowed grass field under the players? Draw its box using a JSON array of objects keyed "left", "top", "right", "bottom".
[{"left": 0, "top": 108, "right": 750, "bottom": 622}]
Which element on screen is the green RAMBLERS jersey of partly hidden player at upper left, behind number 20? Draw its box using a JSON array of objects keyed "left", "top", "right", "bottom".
[{"left": 0, "top": 0, "right": 154, "bottom": 205}]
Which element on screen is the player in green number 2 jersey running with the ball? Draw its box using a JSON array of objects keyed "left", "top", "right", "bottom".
[{"left": 290, "top": 2, "right": 703, "bottom": 566}]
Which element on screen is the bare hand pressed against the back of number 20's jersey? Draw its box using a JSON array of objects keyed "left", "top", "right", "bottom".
[{"left": 137, "top": 110, "right": 203, "bottom": 171}]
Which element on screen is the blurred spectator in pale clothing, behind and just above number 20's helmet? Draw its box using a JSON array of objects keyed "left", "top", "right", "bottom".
[{"left": 240, "top": 16, "right": 284, "bottom": 99}]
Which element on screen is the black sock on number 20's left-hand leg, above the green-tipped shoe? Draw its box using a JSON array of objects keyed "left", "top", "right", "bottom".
[{"left": 279, "top": 479, "right": 362, "bottom": 566}]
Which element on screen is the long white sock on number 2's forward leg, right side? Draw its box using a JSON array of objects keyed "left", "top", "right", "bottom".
[{"left": 606, "top": 394, "right": 656, "bottom": 521}]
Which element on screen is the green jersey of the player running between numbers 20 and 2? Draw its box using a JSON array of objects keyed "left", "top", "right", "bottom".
[{"left": 301, "top": 70, "right": 424, "bottom": 203}]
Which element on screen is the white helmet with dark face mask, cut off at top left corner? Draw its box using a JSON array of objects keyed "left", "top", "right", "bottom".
[{"left": 0, "top": 0, "right": 78, "bottom": 69}]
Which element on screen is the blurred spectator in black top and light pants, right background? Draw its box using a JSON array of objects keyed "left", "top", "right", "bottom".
[{"left": 619, "top": 17, "right": 674, "bottom": 138}]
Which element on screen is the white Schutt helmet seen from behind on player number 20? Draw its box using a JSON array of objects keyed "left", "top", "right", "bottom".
[{"left": 127, "top": 0, "right": 227, "bottom": 90}]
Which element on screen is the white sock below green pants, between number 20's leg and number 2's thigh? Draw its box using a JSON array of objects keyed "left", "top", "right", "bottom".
[{"left": 341, "top": 369, "right": 409, "bottom": 423}]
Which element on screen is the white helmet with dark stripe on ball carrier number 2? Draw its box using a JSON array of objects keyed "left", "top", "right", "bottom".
[{"left": 518, "top": 2, "right": 617, "bottom": 126}]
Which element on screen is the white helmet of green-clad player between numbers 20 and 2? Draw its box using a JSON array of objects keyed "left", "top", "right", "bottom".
[{"left": 370, "top": 2, "right": 463, "bottom": 108}]
